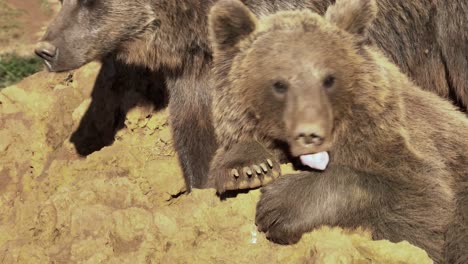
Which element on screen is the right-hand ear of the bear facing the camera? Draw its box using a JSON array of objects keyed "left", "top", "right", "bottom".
[{"left": 325, "top": 0, "right": 377, "bottom": 36}]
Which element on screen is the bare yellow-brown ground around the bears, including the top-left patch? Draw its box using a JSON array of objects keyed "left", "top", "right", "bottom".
[{"left": 0, "top": 0, "right": 431, "bottom": 264}]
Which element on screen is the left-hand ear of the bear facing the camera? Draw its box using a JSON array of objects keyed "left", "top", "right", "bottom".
[{"left": 208, "top": 0, "right": 257, "bottom": 50}]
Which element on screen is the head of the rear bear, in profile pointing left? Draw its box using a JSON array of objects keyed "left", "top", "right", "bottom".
[{"left": 35, "top": 0, "right": 158, "bottom": 72}]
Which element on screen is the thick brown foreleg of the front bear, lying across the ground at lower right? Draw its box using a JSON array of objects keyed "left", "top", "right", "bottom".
[{"left": 255, "top": 165, "right": 446, "bottom": 263}]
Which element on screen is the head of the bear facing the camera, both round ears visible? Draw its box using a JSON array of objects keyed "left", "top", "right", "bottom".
[{"left": 209, "top": 0, "right": 379, "bottom": 156}]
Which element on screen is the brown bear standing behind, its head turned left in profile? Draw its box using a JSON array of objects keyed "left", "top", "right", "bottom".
[{"left": 36, "top": 0, "right": 468, "bottom": 191}]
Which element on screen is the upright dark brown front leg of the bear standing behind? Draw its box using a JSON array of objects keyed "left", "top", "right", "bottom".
[{"left": 167, "top": 75, "right": 217, "bottom": 191}]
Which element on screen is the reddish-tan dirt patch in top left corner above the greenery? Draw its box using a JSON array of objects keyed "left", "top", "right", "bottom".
[{"left": 0, "top": 0, "right": 60, "bottom": 56}]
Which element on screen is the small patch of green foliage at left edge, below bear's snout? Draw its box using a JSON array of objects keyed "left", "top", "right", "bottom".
[{"left": 0, "top": 54, "right": 42, "bottom": 89}]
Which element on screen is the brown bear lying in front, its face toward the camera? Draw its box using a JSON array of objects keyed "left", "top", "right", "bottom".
[{"left": 209, "top": 0, "right": 468, "bottom": 263}]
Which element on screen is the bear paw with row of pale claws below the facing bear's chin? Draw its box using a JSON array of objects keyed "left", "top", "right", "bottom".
[{"left": 210, "top": 142, "right": 281, "bottom": 193}]
